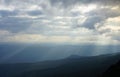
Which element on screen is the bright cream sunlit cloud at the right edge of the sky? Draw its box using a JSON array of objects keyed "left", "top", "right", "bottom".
[{"left": 97, "top": 17, "right": 120, "bottom": 41}]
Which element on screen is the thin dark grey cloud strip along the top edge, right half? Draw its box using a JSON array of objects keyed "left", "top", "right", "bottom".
[{"left": 50, "top": 0, "right": 120, "bottom": 7}]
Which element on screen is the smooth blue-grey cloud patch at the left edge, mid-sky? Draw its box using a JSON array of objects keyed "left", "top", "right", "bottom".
[{"left": 0, "top": 17, "right": 31, "bottom": 33}]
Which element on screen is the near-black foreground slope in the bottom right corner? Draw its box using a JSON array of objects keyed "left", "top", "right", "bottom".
[{"left": 102, "top": 61, "right": 120, "bottom": 77}]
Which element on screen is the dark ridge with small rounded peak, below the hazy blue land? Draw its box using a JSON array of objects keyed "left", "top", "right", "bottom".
[{"left": 0, "top": 53, "right": 120, "bottom": 77}]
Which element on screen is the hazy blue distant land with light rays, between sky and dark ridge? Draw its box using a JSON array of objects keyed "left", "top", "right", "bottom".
[{"left": 0, "top": 43, "right": 120, "bottom": 63}]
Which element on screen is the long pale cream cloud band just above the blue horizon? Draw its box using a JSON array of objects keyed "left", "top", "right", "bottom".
[{"left": 0, "top": 31, "right": 117, "bottom": 45}]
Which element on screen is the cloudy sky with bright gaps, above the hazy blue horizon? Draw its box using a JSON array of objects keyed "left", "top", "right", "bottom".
[{"left": 0, "top": 0, "right": 120, "bottom": 44}]
